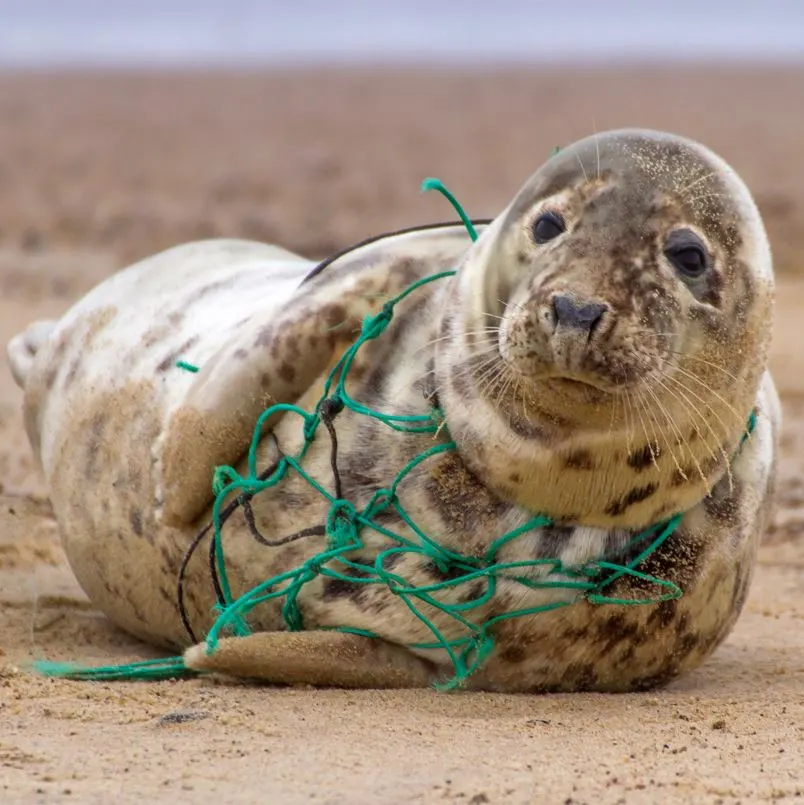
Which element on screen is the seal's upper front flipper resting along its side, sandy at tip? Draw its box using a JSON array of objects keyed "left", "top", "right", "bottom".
[{"left": 159, "top": 226, "right": 467, "bottom": 525}]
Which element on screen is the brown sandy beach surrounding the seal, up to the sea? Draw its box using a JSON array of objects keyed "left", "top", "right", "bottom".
[{"left": 0, "top": 73, "right": 804, "bottom": 805}]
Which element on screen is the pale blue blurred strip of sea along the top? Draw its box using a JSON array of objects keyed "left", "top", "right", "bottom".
[{"left": 0, "top": 0, "right": 804, "bottom": 68}]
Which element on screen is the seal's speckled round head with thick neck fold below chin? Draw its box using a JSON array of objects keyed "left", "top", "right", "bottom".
[{"left": 436, "top": 130, "right": 773, "bottom": 527}]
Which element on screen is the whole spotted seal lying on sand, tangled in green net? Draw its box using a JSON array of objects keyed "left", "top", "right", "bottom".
[{"left": 8, "top": 130, "right": 780, "bottom": 692}]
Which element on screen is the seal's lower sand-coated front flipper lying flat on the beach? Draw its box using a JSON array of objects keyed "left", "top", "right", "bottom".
[{"left": 184, "top": 631, "right": 435, "bottom": 688}]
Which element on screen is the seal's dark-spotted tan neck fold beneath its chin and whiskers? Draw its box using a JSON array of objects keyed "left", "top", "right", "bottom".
[{"left": 437, "top": 367, "right": 752, "bottom": 528}]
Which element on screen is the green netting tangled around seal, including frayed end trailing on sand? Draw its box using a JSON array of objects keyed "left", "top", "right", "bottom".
[{"left": 35, "top": 179, "right": 756, "bottom": 690}]
